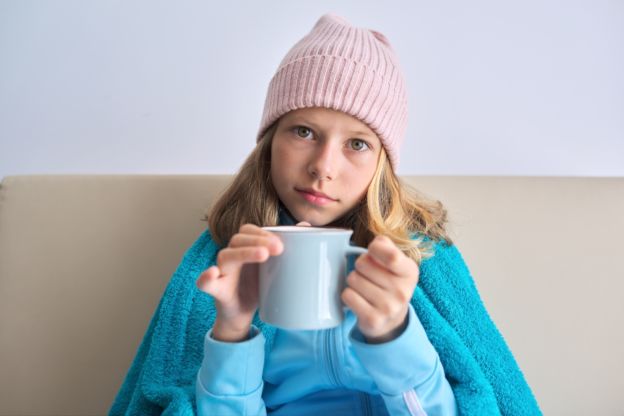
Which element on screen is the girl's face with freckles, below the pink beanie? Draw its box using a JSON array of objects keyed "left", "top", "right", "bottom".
[{"left": 271, "top": 107, "right": 381, "bottom": 226}]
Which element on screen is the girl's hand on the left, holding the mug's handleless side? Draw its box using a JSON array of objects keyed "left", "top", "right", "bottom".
[{"left": 196, "top": 224, "right": 284, "bottom": 341}]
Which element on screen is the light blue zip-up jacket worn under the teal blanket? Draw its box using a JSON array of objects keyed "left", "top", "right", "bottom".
[{"left": 196, "top": 305, "right": 457, "bottom": 416}]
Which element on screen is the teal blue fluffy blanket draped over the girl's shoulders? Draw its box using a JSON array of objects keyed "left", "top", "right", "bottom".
[{"left": 110, "top": 231, "right": 541, "bottom": 416}]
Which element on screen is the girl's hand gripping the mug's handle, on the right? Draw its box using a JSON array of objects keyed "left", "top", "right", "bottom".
[{"left": 341, "top": 236, "right": 420, "bottom": 344}]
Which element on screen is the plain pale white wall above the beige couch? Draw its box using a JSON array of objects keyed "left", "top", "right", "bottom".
[{"left": 0, "top": 0, "right": 624, "bottom": 177}]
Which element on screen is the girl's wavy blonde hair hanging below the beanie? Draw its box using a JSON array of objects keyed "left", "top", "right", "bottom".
[{"left": 203, "top": 122, "right": 452, "bottom": 263}]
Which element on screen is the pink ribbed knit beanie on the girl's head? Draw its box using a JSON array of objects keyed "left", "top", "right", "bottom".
[{"left": 257, "top": 14, "right": 407, "bottom": 172}]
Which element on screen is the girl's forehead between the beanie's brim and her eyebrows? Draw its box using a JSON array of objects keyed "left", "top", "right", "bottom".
[{"left": 282, "top": 107, "right": 377, "bottom": 138}]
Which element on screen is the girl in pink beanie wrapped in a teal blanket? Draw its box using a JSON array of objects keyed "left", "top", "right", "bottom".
[{"left": 111, "top": 14, "right": 540, "bottom": 415}]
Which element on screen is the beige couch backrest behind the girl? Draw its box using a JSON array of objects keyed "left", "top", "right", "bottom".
[{"left": 0, "top": 175, "right": 624, "bottom": 415}]
